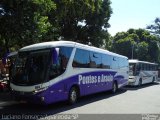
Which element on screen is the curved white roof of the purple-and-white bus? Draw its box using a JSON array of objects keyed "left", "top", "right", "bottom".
[{"left": 19, "top": 41, "right": 128, "bottom": 59}]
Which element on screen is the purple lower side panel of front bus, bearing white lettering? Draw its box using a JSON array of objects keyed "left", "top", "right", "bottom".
[{"left": 12, "top": 71, "right": 127, "bottom": 104}]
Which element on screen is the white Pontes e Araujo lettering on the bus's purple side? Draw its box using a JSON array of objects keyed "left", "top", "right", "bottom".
[{"left": 78, "top": 74, "right": 113, "bottom": 85}]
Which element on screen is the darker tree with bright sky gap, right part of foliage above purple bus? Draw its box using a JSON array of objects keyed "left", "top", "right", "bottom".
[{"left": 55, "top": 0, "right": 112, "bottom": 46}]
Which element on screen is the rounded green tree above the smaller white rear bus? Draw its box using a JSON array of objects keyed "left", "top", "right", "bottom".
[{"left": 112, "top": 29, "right": 159, "bottom": 62}]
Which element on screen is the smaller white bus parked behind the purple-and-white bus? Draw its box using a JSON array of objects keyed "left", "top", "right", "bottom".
[{"left": 128, "top": 59, "right": 158, "bottom": 86}]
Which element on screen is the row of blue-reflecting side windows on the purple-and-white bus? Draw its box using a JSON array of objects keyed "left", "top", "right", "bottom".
[{"left": 72, "top": 49, "right": 128, "bottom": 69}]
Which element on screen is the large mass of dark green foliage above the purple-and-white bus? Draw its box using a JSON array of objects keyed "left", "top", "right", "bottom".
[{"left": 0, "top": 0, "right": 112, "bottom": 57}]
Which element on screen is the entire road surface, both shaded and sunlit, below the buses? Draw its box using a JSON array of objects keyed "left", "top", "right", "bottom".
[{"left": 0, "top": 83, "right": 160, "bottom": 120}]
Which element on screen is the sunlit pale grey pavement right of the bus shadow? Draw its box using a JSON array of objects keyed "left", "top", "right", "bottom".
[{"left": 61, "top": 83, "right": 160, "bottom": 114}]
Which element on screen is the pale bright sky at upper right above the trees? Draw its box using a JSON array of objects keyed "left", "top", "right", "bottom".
[{"left": 108, "top": 0, "right": 160, "bottom": 36}]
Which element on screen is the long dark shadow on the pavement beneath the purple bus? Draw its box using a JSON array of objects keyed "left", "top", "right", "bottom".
[{"left": 0, "top": 89, "right": 126, "bottom": 119}]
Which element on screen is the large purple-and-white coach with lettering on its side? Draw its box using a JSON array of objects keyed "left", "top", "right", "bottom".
[{"left": 10, "top": 41, "right": 129, "bottom": 104}]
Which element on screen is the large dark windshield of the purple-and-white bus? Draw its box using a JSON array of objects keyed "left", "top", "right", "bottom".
[{"left": 11, "top": 50, "right": 50, "bottom": 85}]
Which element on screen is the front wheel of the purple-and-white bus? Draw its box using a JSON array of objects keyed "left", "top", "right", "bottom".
[{"left": 68, "top": 87, "right": 78, "bottom": 105}]
